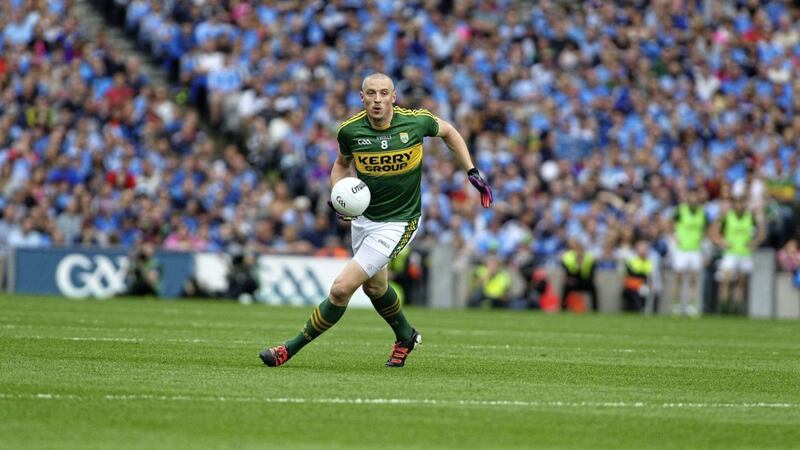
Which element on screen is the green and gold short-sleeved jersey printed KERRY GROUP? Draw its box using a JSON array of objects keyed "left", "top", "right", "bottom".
[{"left": 337, "top": 106, "right": 439, "bottom": 222}]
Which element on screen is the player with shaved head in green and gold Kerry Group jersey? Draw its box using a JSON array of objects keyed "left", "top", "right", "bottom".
[{"left": 259, "top": 73, "right": 493, "bottom": 367}]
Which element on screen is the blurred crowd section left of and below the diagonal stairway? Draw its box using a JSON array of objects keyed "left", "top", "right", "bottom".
[{"left": 0, "top": 1, "right": 354, "bottom": 254}]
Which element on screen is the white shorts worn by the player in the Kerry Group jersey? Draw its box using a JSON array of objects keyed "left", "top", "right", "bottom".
[{"left": 350, "top": 216, "right": 420, "bottom": 278}]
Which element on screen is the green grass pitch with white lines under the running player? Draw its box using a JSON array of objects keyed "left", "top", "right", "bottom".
[{"left": 0, "top": 296, "right": 800, "bottom": 449}]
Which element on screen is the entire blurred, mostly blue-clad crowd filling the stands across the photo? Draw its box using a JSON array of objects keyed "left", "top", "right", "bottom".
[{"left": 0, "top": 0, "right": 800, "bottom": 302}]
